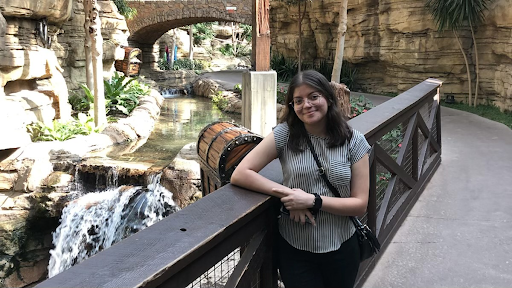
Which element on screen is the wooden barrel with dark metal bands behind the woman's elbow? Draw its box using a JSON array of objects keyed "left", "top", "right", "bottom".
[{"left": 197, "top": 121, "right": 263, "bottom": 196}]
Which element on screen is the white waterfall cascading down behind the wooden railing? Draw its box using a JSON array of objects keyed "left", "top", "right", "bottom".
[{"left": 48, "top": 174, "right": 178, "bottom": 277}]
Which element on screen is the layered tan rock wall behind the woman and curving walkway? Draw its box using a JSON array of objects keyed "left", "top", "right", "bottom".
[{"left": 270, "top": 0, "right": 512, "bottom": 111}]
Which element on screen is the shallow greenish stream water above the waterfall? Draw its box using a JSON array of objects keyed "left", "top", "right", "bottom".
[{"left": 109, "top": 96, "right": 241, "bottom": 166}]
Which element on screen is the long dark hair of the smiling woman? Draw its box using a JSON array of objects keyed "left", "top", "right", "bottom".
[{"left": 279, "top": 70, "right": 352, "bottom": 152}]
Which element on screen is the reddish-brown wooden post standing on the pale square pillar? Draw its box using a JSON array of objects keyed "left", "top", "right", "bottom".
[{"left": 252, "top": 0, "right": 270, "bottom": 71}]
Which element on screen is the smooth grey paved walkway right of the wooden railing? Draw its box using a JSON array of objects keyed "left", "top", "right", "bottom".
[{"left": 363, "top": 96, "right": 512, "bottom": 288}]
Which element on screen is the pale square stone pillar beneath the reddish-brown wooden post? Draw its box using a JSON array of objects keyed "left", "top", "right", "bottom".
[{"left": 242, "top": 71, "right": 277, "bottom": 136}]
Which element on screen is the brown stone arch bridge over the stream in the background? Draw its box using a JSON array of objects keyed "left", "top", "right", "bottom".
[{"left": 127, "top": 0, "right": 252, "bottom": 44}]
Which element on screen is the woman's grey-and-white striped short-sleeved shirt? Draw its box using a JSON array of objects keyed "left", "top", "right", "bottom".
[{"left": 274, "top": 123, "right": 370, "bottom": 253}]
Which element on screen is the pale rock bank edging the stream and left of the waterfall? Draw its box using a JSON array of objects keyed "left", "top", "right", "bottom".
[{"left": 0, "top": 90, "right": 164, "bottom": 288}]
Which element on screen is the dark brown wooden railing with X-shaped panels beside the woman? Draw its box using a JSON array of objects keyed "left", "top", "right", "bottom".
[{"left": 37, "top": 79, "right": 441, "bottom": 288}]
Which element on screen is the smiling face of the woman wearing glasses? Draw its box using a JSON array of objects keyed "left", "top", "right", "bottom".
[{"left": 291, "top": 84, "right": 329, "bottom": 125}]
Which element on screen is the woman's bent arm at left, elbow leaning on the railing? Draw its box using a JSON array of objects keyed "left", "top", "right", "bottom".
[{"left": 231, "top": 132, "right": 291, "bottom": 198}]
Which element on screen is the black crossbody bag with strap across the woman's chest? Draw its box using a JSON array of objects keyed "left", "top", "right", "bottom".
[{"left": 306, "top": 137, "right": 380, "bottom": 262}]
